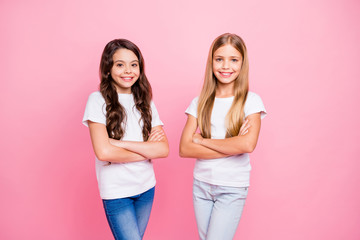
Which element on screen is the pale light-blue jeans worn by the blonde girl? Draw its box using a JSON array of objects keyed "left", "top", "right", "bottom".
[{"left": 193, "top": 179, "right": 248, "bottom": 240}]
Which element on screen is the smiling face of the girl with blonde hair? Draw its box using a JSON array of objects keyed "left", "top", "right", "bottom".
[{"left": 213, "top": 44, "right": 242, "bottom": 85}]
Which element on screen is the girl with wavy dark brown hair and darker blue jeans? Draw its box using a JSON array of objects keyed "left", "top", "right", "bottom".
[{"left": 83, "top": 39, "right": 169, "bottom": 240}]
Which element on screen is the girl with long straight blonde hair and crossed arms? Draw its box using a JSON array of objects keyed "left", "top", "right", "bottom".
[{"left": 180, "top": 33, "right": 266, "bottom": 240}]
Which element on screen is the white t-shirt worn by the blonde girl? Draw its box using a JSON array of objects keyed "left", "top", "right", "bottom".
[{"left": 185, "top": 92, "right": 266, "bottom": 187}]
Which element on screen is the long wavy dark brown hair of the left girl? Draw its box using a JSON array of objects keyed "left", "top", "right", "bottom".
[{"left": 99, "top": 39, "right": 152, "bottom": 141}]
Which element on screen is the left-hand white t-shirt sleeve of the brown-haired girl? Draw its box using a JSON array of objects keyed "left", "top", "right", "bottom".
[{"left": 82, "top": 92, "right": 106, "bottom": 127}]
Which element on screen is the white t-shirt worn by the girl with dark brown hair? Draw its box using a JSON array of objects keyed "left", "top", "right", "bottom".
[{"left": 82, "top": 91, "right": 163, "bottom": 199}]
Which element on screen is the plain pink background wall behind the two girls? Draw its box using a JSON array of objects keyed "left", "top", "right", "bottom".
[{"left": 0, "top": 0, "right": 360, "bottom": 240}]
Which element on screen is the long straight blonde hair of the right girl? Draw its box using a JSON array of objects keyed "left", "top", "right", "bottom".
[{"left": 197, "top": 33, "right": 249, "bottom": 138}]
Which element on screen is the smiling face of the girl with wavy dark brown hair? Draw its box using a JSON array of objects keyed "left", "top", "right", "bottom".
[{"left": 110, "top": 48, "right": 140, "bottom": 93}]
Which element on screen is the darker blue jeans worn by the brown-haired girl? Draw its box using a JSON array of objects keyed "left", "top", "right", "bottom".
[{"left": 103, "top": 187, "right": 155, "bottom": 240}]
